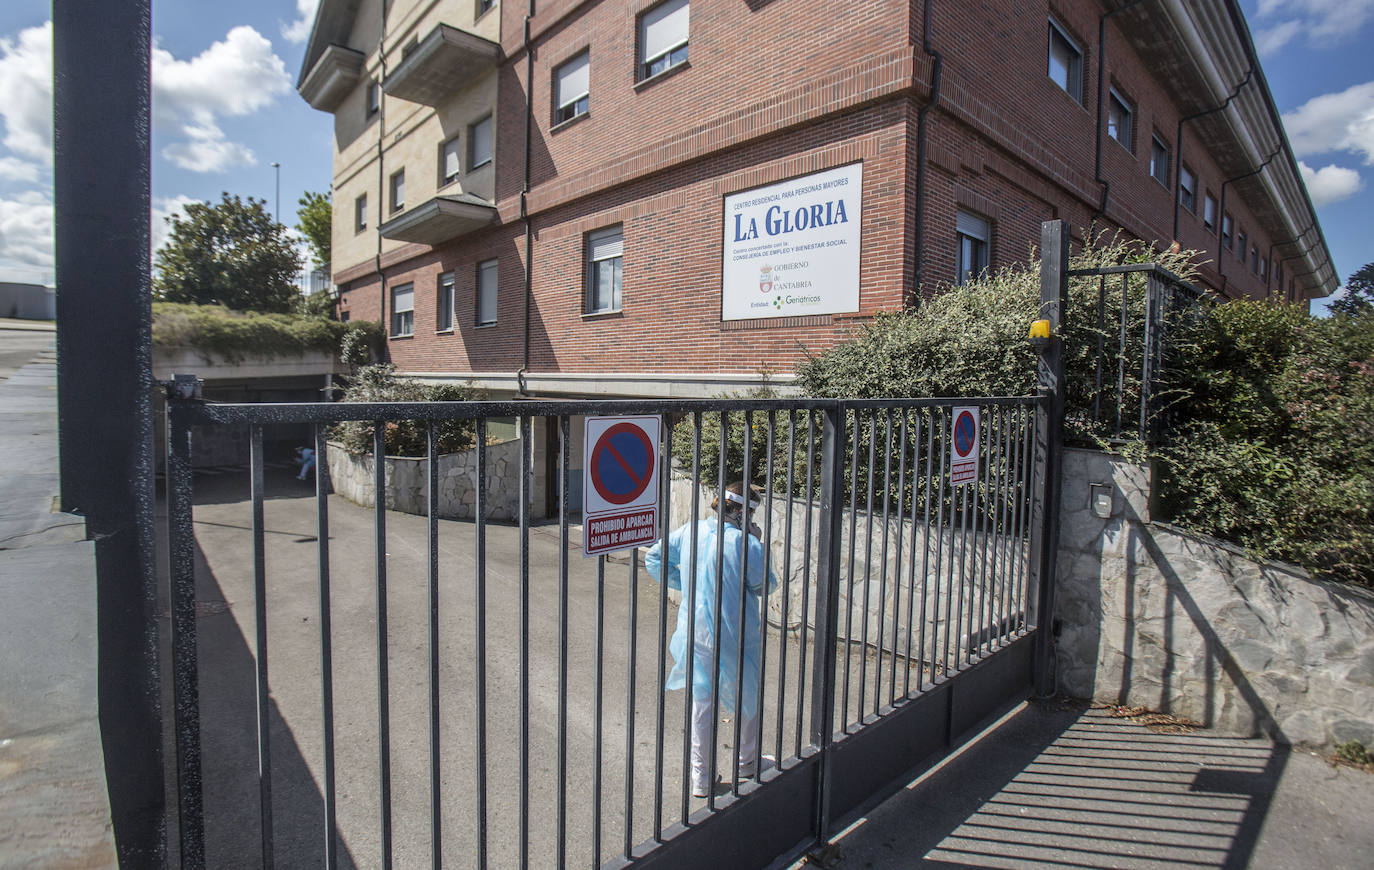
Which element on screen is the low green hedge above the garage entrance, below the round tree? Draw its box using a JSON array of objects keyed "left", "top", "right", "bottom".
[{"left": 153, "top": 302, "right": 383, "bottom": 363}]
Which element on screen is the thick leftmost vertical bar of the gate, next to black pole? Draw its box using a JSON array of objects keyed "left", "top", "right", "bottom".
[{"left": 166, "top": 401, "right": 205, "bottom": 870}]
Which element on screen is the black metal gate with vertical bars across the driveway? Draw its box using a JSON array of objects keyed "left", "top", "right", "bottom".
[{"left": 166, "top": 397, "right": 1047, "bottom": 869}]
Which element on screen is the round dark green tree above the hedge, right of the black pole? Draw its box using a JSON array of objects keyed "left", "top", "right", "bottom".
[{"left": 153, "top": 192, "right": 301, "bottom": 313}]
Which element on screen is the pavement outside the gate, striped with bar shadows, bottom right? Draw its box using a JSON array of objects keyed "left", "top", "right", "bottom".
[{"left": 797, "top": 701, "right": 1374, "bottom": 870}]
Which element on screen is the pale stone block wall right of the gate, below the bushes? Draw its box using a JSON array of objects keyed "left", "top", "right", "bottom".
[{"left": 1055, "top": 449, "right": 1374, "bottom": 746}]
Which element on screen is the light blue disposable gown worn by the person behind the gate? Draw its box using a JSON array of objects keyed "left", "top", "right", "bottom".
[{"left": 644, "top": 517, "right": 778, "bottom": 717}]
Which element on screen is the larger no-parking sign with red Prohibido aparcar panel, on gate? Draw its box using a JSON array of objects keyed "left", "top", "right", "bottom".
[{"left": 583, "top": 416, "right": 662, "bottom": 557}]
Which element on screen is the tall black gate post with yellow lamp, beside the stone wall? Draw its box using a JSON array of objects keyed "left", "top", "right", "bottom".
[{"left": 1026, "top": 220, "right": 1069, "bottom": 697}]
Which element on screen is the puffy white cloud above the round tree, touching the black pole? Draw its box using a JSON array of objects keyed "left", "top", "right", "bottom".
[{"left": 153, "top": 26, "right": 291, "bottom": 172}]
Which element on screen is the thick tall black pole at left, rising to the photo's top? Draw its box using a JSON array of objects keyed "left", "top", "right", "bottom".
[{"left": 52, "top": 0, "right": 166, "bottom": 867}]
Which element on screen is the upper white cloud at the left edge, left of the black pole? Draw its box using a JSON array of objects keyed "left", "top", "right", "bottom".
[{"left": 0, "top": 21, "right": 52, "bottom": 165}]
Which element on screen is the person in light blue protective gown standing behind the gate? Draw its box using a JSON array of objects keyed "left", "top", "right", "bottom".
[{"left": 644, "top": 481, "right": 778, "bottom": 797}]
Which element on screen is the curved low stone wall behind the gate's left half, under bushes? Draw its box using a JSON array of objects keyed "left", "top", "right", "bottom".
[{"left": 328, "top": 438, "right": 523, "bottom": 520}]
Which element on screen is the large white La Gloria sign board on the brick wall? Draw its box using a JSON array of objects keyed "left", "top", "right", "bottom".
[{"left": 720, "top": 164, "right": 863, "bottom": 320}]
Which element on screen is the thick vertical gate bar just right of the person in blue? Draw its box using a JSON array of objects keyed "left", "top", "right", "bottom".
[{"left": 808, "top": 401, "right": 848, "bottom": 845}]
